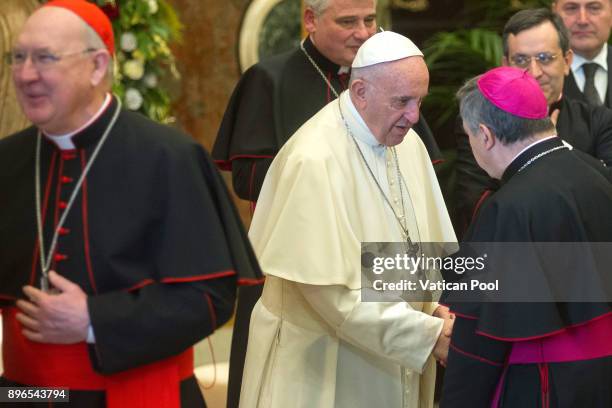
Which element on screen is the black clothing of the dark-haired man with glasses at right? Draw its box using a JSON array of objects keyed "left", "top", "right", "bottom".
[{"left": 453, "top": 98, "right": 612, "bottom": 236}]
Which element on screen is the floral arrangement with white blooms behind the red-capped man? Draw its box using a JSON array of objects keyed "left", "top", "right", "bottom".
[{"left": 42, "top": 0, "right": 183, "bottom": 123}]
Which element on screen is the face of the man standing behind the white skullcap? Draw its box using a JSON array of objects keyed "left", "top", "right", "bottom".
[{"left": 304, "top": 0, "right": 376, "bottom": 66}]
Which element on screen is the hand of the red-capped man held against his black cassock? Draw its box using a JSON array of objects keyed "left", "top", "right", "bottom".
[{"left": 17, "top": 271, "right": 90, "bottom": 344}]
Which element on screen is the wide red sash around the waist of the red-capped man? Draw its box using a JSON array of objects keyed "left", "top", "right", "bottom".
[{"left": 2, "top": 308, "right": 193, "bottom": 408}]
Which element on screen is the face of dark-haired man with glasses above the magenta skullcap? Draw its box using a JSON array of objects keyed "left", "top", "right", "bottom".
[{"left": 504, "top": 21, "right": 572, "bottom": 105}]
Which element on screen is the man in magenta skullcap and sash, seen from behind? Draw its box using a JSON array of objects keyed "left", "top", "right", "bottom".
[{"left": 440, "top": 67, "right": 612, "bottom": 408}]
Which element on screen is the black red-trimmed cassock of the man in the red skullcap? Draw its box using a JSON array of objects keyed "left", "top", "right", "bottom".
[{"left": 0, "top": 99, "right": 261, "bottom": 407}]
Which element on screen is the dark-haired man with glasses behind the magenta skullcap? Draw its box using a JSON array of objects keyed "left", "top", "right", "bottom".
[{"left": 455, "top": 8, "right": 612, "bottom": 233}]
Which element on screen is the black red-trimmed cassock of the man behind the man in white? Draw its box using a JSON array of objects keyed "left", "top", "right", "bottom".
[{"left": 212, "top": 38, "right": 442, "bottom": 201}]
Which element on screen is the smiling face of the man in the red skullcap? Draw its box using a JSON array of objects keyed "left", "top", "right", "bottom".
[{"left": 11, "top": 7, "right": 99, "bottom": 134}]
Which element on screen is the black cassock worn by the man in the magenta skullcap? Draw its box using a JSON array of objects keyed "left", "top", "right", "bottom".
[{"left": 440, "top": 138, "right": 612, "bottom": 408}]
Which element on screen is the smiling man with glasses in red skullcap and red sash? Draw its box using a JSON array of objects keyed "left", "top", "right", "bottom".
[{"left": 0, "top": 0, "right": 258, "bottom": 408}]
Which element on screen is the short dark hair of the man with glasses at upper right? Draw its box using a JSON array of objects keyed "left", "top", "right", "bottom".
[{"left": 502, "top": 8, "right": 570, "bottom": 57}]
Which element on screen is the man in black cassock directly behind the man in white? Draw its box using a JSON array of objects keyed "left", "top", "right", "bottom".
[{"left": 212, "top": 0, "right": 442, "bottom": 202}]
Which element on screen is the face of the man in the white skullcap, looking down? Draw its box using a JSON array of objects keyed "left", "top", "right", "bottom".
[{"left": 363, "top": 57, "right": 429, "bottom": 146}]
